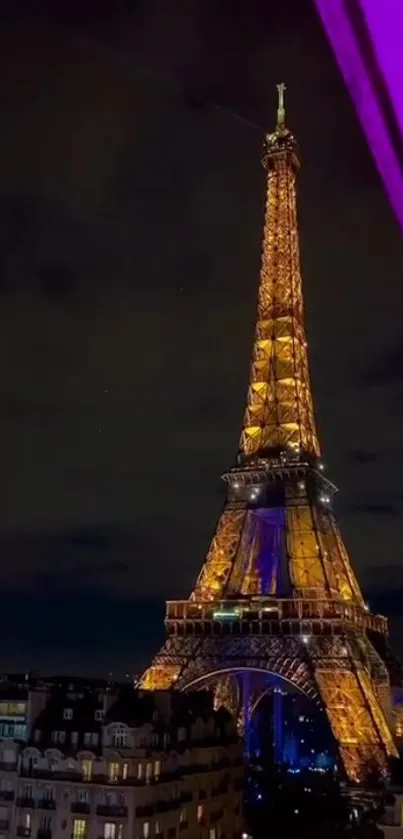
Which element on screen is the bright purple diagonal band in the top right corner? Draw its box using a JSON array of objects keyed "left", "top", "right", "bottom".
[{"left": 316, "top": 0, "right": 403, "bottom": 232}]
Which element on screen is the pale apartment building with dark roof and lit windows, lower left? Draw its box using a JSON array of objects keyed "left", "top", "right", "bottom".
[{"left": 0, "top": 682, "right": 243, "bottom": 839}]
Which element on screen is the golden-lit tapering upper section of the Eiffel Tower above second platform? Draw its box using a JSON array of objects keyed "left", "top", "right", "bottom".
[{"left": 240, "top": 142, "right": 320, "bottom": 457}]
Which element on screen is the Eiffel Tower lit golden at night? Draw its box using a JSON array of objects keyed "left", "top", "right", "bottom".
[{"left": 140, "top": 84, "right": 396, "bottom": 781}]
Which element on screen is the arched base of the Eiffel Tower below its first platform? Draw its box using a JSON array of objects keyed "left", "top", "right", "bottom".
[{"left": 142, "top": 632, "right": 396, "bottom": 780}]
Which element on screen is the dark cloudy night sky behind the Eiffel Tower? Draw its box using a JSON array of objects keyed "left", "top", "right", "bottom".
[{"left": 0, "top": 0, "right": 403, "bottom": 671}]
